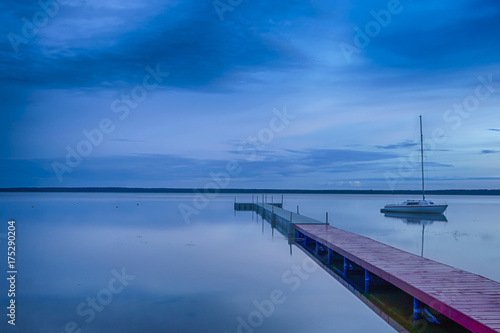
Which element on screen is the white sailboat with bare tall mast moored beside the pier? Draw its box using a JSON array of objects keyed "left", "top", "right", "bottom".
[{"left": 381, "top": 116, "right": 448, "bottom": 214}]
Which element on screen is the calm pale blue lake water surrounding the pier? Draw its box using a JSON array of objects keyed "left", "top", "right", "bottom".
[{"left": 0, "top": 194, "right": 500, "bottom": 333}]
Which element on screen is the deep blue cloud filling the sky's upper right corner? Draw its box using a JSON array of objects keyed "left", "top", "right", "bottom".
[{"left": 366, "top": 0, "right": 500, "bottom": 69}]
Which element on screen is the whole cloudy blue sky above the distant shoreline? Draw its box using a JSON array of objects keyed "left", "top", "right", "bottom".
[{"left": 0, "top": 0, "right": 500, "bottom": 190}]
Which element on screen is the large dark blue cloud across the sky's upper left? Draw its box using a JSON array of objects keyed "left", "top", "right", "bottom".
[{"left": 0, "top": 1, "right": 307, "bottom": 88}]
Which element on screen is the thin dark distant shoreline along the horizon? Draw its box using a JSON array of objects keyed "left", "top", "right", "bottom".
[{"left": 0, "top": 187, "right": 500, "bottom": 195}]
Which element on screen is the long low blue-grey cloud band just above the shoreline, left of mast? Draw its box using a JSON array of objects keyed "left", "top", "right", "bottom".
[{"left": 0, "top": 149, "right": 396, "bottom": 187}]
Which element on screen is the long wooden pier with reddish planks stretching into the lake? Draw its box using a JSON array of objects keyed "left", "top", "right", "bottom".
[{"left": 235, "top": 203, "right": 500, "bottom": 333}]
